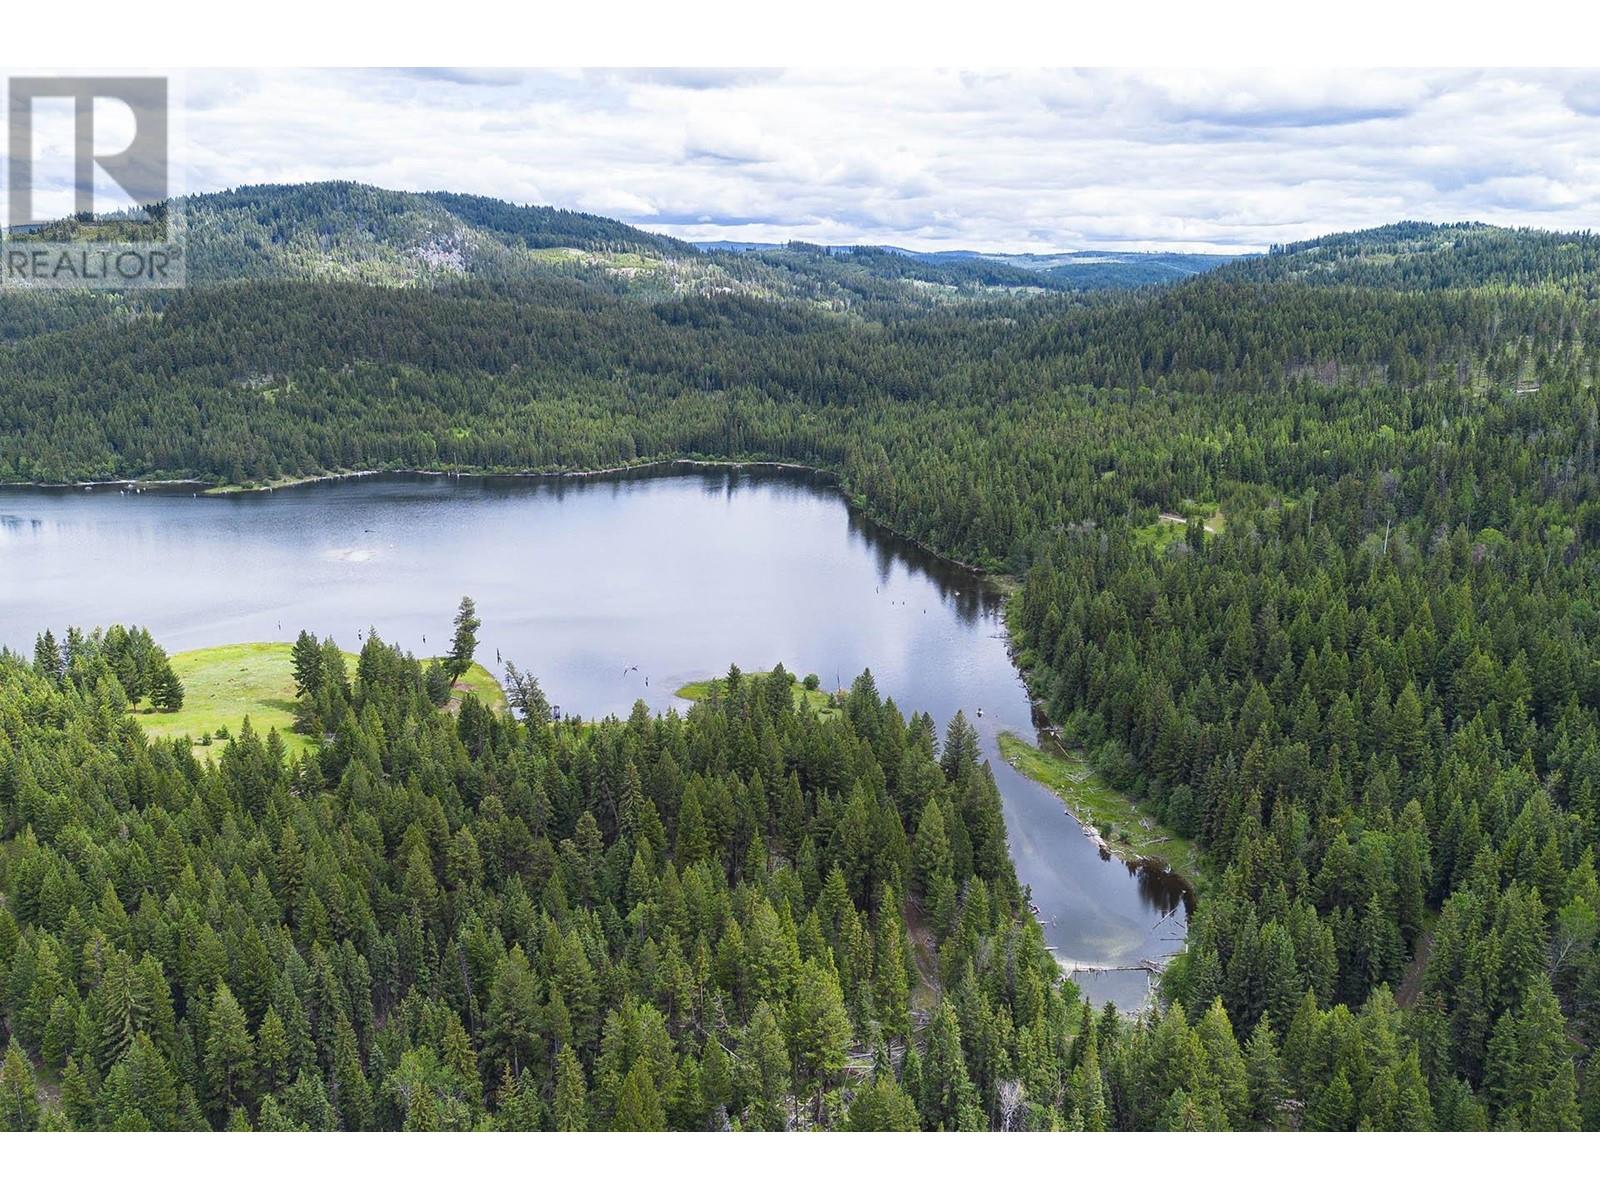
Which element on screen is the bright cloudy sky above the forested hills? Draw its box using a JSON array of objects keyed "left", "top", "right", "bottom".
[{"left": 112, "top": 70, "right": 1600, "bottom": 251}]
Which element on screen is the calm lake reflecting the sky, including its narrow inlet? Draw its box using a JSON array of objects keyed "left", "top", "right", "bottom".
[{"left": 0, "top": 470, "right": 1186, "bottom": 1008}]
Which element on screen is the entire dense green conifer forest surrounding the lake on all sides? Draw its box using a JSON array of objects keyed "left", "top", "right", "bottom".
[{"left": 0, "top": 185, "right": 1600, "bottom": 1130}]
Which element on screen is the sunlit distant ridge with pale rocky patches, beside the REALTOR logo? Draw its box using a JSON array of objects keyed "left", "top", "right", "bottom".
[{"left": 6, "top": 181, "right": 1230, "bottom": 310}]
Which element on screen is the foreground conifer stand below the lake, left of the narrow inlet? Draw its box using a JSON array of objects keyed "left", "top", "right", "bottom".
[{"left": 0, "top": 634, "right": 1088, "bottom": 1130}]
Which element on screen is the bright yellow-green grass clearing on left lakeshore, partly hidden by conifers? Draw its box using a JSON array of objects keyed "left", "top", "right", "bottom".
[{"left": 134, "top": 642, "right": 506, "bottom": 757}]
